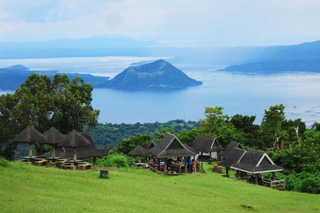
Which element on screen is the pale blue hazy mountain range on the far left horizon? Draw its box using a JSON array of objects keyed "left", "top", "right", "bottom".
[{"left": 0, "top": 34, "right": 161, "bottom": 59}]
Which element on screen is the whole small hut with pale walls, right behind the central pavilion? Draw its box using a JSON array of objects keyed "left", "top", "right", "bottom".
[{"left": 192, "top": 136, "right": 224, "bottom": 159}]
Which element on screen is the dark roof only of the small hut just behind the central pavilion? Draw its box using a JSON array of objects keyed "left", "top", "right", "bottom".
[{"left": 192, "top": 136, "right": 224, "bottom": 152}]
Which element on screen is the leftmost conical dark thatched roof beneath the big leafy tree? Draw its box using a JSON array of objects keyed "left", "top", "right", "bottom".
[{"left": 12, "top": 125, "right": 46, "bottom": 143}]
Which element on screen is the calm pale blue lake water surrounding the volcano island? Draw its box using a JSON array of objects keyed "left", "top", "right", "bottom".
[{"left": 0, "top": 57, "right": 320, "bottom": 126}]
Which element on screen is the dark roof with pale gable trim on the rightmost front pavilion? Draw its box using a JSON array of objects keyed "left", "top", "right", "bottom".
[{"left": 230, "top": 149, "right": 283, "bottom": 174}]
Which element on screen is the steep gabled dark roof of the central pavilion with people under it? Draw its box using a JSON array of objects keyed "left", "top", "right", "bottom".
[{"left": 149, "top": 133, "right": 196, "bottom": 158}]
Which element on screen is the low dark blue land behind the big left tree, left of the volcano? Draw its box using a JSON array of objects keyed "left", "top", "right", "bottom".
[{"left": 0, "top": 65, "right": 109, "bottom": 90}]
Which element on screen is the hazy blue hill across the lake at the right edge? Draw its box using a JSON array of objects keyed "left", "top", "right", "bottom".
[{"left": 220, "top": 41, "right": 320, "bottom": 74}]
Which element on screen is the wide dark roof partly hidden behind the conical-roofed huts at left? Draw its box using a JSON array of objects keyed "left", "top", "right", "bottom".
[{"left": 42, "top": 132, "right": 108, "bottom": 159}]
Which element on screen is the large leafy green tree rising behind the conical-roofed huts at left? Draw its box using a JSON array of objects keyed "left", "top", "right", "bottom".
[{"left": 0, "top": 73, "right": 100, "bottom": 157}]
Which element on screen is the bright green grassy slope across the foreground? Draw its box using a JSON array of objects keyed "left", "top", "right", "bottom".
[{"left": 0, "top": 162, "right": 320, "bottom": 212}]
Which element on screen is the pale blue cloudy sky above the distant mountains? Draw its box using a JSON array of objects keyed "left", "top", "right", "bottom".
[{"left": 0, "top": 0, "right": 320, "bottom": 47}]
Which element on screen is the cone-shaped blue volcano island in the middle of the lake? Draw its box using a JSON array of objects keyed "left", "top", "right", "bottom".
[{"left": 101, "top": 60, "right": 202, "bottom": 90}]
